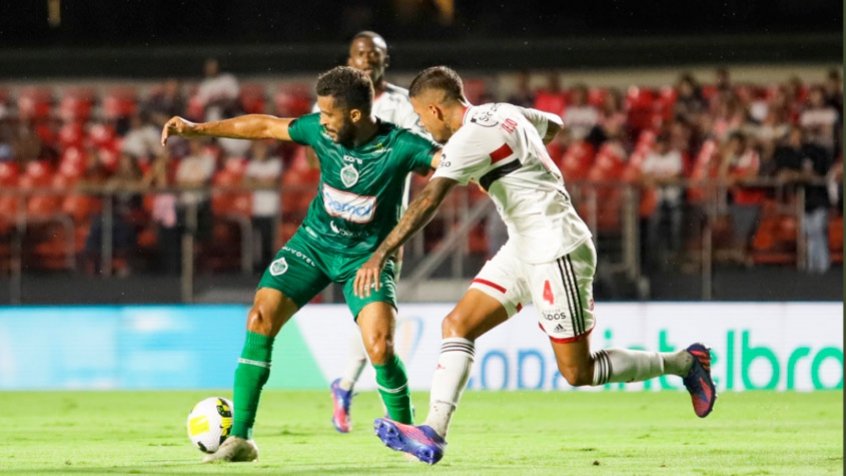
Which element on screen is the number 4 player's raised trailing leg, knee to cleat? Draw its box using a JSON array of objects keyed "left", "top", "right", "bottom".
[{"left": 550, "top": 335, "right": 717, "bottom": 417}]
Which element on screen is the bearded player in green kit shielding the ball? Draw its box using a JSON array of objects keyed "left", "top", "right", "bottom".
[{"left": 162, "top": 66, "right": 440, "bottom": 462}]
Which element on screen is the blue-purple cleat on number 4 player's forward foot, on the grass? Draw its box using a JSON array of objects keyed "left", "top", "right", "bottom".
[{"left": 373, "top": 418, "right": 446, "bottom": 464}]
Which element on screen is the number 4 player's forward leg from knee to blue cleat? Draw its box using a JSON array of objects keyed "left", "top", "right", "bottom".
[{"left": 374, "top": 289, "right": 508, "bottom": 464}]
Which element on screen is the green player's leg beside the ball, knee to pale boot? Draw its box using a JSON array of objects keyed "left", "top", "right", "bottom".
[{"left": 203, "top": 288, "right": 297, "bottom": 463}]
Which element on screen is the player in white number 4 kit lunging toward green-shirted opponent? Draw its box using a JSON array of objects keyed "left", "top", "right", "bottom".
[{"left": 355, "top": 66, "right": 716, "bottom": 464}]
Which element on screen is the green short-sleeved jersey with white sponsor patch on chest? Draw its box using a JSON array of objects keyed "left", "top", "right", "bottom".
[{"left": 288, "top": 114, "right": 438, "bottom": 256}]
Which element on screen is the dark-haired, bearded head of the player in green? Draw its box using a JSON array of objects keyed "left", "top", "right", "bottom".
[{"left": 315, "top": 66, "right": 373, "bottom": 144}]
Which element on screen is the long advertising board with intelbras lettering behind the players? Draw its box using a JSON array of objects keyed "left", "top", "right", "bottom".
[{"left": 0, "top": 302, "right": 843, "bottom": 391}]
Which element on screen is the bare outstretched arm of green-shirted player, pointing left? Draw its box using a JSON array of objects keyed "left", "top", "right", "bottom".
[{"left": 162, "top": 114, "right": 294, "bottom": 146}]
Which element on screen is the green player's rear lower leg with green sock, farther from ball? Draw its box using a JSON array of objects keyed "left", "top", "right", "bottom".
[{"left": 356, "top": 302, "right": 413, "bottom": 423}]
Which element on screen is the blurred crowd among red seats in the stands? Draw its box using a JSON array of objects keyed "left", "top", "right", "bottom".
[{"left": 0, "top": 64, "right": 843, "bottom": 274}]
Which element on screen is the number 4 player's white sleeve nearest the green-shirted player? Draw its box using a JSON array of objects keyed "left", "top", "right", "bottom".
[{"left": 432, "top": 126, "right": 494, "bottom": 185}]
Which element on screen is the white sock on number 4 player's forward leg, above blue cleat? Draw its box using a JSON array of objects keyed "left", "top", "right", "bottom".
[{"left": 424, "top": 337, "right": 475, "bottom": 437}]
